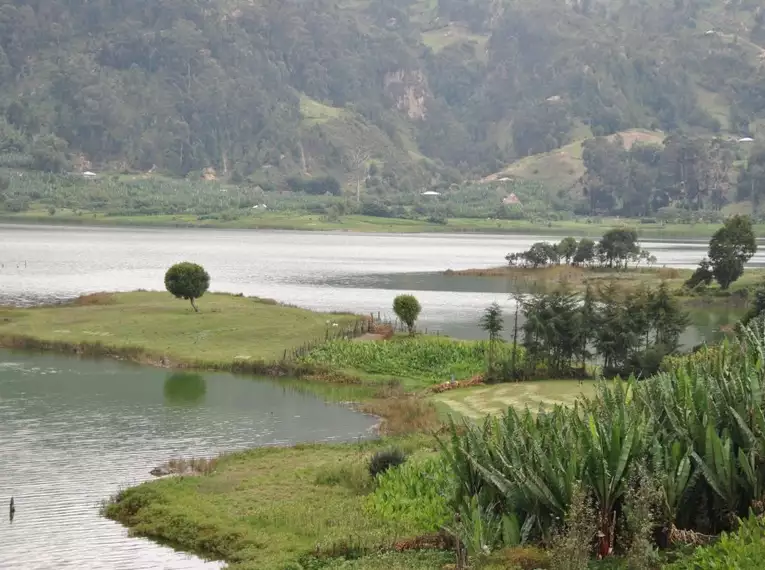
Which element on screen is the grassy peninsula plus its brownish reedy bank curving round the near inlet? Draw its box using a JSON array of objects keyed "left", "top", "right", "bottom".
[{"left": 0, "top": 292, "right": 442, "bottom": 434}]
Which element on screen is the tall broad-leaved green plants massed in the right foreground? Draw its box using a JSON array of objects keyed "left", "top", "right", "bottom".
[{"left": 442, "top": 326, "right": 765, "bottom": 557}]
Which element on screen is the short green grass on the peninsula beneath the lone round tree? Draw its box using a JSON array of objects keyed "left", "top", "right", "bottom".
[{"left": 0, "top": 292, "right": 357, "bottom": 365}]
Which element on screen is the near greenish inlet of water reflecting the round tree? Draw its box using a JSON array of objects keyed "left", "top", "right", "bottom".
[{"left": 0, "top": 350, "right": 375, "bottom": 570}]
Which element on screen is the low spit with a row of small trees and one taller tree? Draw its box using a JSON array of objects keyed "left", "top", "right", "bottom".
[{"left": 444, "top": 216, "right": 765, "bottom": 306}]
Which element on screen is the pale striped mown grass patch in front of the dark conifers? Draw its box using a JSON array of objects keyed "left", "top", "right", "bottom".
[{"left": 432, "top": 380, "right": 596, "bottom": 419}]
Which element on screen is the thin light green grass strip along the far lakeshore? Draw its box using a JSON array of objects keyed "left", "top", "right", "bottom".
[{"left": 0, "top": 210, "right": 752, "bottom": 240}]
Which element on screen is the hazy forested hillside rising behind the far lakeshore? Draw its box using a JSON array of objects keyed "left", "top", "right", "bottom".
[{"left": 0, "top": 0, "right": 765, "bottom": 197}]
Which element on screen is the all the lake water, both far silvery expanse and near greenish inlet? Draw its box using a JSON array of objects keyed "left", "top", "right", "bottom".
[{"left": 0, "top": 225, "right": 752, "bottom": 570}]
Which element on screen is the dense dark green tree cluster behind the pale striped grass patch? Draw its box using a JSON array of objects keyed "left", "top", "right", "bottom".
[{"left": 508, "top": 283, "right": 688, "bottom": 379}]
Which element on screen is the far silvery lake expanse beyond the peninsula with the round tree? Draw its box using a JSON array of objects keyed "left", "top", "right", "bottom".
[{"left": 0, "top": 224, "right": 752, "bottom": 345}]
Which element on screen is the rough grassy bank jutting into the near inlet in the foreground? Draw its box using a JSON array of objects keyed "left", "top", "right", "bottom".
[{"left": 106, "top": 438, "right": 448, "bottom": 570}]
